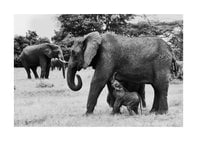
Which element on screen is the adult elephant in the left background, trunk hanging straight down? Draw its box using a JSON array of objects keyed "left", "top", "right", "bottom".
[{"left": 19, "top": 43, "right": 65, "bottom": 79}]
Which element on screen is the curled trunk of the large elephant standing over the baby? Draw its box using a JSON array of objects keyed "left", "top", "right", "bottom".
[{"left": 67, "top": 64, "right": 82, "bottom": 91}]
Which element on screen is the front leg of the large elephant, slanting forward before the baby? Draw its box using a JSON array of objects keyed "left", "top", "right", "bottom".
[{"left": 86, "top": 71, "right": 109, "bottom": 115}]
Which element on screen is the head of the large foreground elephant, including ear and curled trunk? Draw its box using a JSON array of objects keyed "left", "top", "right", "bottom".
[{"left": 67, "top": 32, "right": 101, "bottom": 91}]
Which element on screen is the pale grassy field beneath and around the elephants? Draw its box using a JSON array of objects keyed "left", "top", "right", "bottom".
[{"left": 14, "top": 68, "right": 183, "bottom": 127}]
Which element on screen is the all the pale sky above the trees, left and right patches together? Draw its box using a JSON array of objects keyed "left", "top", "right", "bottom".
[{"left": 14, "top": 14, "right": 183, "bottom": 39}]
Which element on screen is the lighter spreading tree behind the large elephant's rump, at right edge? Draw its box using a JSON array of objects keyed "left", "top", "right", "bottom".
[{"left": 123, "top": 17, "right": 183, "bottom": 61}]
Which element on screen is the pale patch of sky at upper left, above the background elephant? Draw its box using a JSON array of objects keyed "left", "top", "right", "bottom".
[{"left": 14, "top": 14, "right": 58, "bottom": 39}]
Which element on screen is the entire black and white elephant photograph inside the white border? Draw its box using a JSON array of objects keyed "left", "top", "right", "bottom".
[{"left": 13, "top": 14, "right": 184, "bottom": 127}]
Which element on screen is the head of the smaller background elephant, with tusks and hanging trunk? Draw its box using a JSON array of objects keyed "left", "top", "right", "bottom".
[{"left": 42, "top": 43, "right": 66, "bottom": 78}]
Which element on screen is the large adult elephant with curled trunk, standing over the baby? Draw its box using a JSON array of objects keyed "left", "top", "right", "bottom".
[{"left": 67, "top": 32, "right": 175, "bottom": 114}]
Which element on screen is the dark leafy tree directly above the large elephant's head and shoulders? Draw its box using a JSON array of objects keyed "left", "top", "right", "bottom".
[{"left": 52, "top": 14, "right": 136, "bottom": 42}]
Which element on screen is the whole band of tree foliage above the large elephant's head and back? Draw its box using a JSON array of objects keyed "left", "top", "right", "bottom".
[{"left": 52, "top": 14, "right": 183, "bottom": 60}]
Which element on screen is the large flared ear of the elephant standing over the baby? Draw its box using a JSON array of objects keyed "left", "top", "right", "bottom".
[{"left": 83, "top": 32, "right": 101, "bottom": 69}]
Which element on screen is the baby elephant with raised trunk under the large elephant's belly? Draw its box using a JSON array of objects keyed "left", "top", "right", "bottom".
[{"left": 111, "top": 73, "right": 142, "bottom": 115}]
